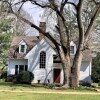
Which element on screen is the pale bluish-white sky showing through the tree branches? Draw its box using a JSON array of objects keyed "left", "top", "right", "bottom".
[{"left": 13, "top": 0, "right": 78, "bottom": 34}]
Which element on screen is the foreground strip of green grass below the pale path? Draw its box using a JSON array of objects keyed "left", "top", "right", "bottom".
[{"left": 0, "top": 93, "right": 100, "bottom": 100}]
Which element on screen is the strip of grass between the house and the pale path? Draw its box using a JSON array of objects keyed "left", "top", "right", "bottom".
[{"left": 0, "top": 80, "right": 96, "bottom": 92}]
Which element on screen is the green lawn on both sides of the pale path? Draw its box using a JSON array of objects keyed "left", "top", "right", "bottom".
[{"left": 0, "top": 81, "right": 100, "bottom": 100}]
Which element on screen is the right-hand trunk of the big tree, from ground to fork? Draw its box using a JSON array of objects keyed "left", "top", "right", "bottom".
[{"left": 70, "top": 51, "right": 82, "bottom": 87}]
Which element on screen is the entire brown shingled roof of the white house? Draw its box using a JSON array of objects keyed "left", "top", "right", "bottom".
[{"left": 9, "top": 36, "right": 92, "bottom": 61}]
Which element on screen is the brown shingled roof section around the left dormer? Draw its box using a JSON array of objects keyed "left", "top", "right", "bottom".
[{"left": 9, "top": 36, "right": 39, "bottom": 59}]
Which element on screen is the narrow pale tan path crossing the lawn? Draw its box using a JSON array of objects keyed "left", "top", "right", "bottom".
[{"left": 0, "top": 90, "right": 100, "bottom": 95}]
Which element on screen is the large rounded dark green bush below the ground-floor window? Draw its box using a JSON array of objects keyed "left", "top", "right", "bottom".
[{"left": 16, "top": 71, "right": 34, "bottom": 84}]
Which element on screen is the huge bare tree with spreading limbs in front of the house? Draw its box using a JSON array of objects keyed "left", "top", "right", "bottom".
[{"left": 2, "top": 0, "right": 100, "bottom": 88}]
